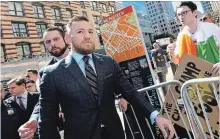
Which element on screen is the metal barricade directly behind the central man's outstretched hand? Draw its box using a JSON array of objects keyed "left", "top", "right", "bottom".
[{"left": 117, "top": 80, "right": 192, "bottom": 139}]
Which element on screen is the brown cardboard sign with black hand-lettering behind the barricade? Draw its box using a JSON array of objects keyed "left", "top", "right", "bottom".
[{"left": 161, "top": 54, "right": 219, "bottom": 139}]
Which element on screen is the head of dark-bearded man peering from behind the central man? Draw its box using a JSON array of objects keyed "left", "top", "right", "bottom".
[{"left": 43, "top": 27, "right": 68, "bottom": 57}]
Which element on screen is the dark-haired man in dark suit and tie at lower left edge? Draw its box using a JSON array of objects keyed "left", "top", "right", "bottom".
[{"left": 1, "top": 77, "right": 39, "bottom": 139}]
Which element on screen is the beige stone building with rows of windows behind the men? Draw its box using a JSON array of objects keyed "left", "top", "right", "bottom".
[{"left": 0, "top": 1, "right": 115, "bottom": 62}]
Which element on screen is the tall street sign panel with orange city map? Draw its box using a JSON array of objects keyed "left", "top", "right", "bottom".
[{"left": 101, "top": 6, "right": 161, "bottom": 138}]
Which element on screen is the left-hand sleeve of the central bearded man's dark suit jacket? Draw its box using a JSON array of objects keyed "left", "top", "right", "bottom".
[{"left": 39, "top": 70, "right": 60, "bottom": 139}]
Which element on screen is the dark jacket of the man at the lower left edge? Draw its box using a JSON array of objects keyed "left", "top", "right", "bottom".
[{"left": 1, "top": 93, "right": 39, "bottom": 139}]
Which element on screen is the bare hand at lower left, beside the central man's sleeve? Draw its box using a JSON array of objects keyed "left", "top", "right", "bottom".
[{"left": 18, "top": 120, "right": 37, "bottom": 139}]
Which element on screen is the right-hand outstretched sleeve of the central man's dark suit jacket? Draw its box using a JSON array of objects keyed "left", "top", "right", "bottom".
[{"left": 113, "top": 60, "right": 156, "bottom": 118}]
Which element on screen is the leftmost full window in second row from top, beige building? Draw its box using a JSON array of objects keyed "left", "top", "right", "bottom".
[{"left": 12, "top": 22, "right": 28, "bottom": 37}]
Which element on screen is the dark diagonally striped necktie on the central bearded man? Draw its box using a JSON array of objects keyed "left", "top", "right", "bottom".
[{"left": 83, "top": 56, "right": 98, "bottom": 100}]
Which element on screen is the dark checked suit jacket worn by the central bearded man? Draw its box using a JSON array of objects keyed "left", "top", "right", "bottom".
[{"left": 39, "top": 54, "right": 155, "bottom": 139}]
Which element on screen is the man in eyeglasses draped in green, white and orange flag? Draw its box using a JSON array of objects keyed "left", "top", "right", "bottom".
[{"left": 167, "top": 1, "right": 220, "bottom": 74}]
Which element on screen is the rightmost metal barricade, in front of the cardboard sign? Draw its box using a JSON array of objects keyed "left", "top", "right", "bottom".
[{"left": 181, "top": 77, "right": 220, "bottom": 139}]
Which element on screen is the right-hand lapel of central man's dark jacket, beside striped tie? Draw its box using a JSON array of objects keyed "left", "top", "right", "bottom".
[{"left": 93, "top": 54, "right": 104, "bottom": 105}]
